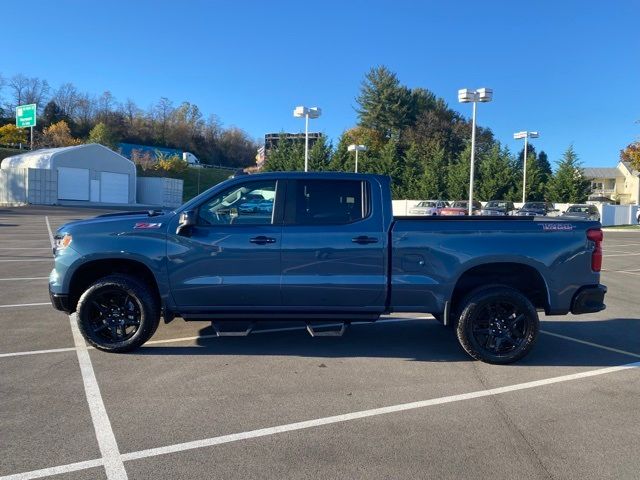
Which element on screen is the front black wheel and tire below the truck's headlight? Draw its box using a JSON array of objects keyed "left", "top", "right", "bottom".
[{"left": 77, "top": 275, "right": 160, "bottom": 352}]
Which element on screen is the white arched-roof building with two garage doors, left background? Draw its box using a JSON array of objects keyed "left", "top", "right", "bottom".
[{"left": 1, "top": 143, "right": 136, "bottom": 204}]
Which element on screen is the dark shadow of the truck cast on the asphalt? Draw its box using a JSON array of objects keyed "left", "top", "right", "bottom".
[{"left": 135, "top": 318, "right": 640, "bottom": 367}]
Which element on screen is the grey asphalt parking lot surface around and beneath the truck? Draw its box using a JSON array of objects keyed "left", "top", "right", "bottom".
[{"left": 0, "top": 208, "right": 640, "bottom": 480}]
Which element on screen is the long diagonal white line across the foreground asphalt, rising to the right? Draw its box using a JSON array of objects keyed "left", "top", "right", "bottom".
[{"left": 0, "top": 362, "right": 640, "bottom": 480}]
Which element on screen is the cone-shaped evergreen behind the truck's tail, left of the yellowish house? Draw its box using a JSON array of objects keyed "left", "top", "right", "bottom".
[{"left": 549, "top": 145, "right": 591, "bottom": 203}]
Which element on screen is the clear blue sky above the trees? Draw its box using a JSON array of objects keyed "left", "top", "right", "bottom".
[{"left": 0, "top": 0, "right": 640, "bottom": 166}]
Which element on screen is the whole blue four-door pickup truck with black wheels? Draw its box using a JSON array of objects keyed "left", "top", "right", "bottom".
[{"left": 49, "top": 172, "right": 606, "bottom": 363}]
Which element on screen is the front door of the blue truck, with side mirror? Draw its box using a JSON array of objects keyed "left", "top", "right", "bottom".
[{"left": 167, "top": 180, "right": 284, "bottom": 311}]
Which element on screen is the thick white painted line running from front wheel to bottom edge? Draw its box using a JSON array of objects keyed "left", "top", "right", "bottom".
[{"left": 69, "top": 316, "right": 128, "bottom": 480}]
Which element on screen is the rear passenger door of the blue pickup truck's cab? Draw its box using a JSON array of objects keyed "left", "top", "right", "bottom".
[{"left": 282, "top": 179, "right": 387, "bottom": 311}]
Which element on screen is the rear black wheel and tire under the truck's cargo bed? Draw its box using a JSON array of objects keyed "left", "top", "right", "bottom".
[{"left": 456, "top": 286, "right": 540, "bottom": 365}]
